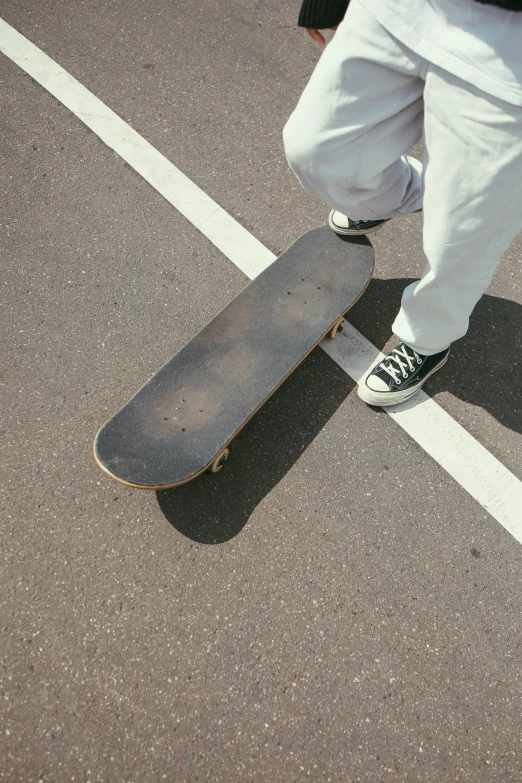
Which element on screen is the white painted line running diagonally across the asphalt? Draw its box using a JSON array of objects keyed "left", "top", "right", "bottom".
[{"left": 4, "top": 20, "right": 522, "bottom": 543}]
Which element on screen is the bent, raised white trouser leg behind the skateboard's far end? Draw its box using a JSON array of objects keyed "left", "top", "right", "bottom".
[{"left": 283, "top": 0, "right": 427, "bottom": 220}]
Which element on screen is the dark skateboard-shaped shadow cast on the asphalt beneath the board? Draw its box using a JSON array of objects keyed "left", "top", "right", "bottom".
[{"left": 156, "top": 348, "right": 355, "bottom": 544}]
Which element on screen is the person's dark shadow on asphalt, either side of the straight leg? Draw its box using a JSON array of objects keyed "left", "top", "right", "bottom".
[{"left": 350, "top": 278, "right": 522, "bottom": 433}]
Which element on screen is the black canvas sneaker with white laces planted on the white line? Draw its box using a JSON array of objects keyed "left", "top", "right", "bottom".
[{"left": 357, "top": 343, "right": 450, "bottom": 406}]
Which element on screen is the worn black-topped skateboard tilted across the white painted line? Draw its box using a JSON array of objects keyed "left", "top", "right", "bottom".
[{"left": 94, "top": 226, "right": 373, "bottom": 489}]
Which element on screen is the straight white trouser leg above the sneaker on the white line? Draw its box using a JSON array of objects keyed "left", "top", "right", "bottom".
[{"left": 393, "top": 65, "right": 522, "bottom": 354}]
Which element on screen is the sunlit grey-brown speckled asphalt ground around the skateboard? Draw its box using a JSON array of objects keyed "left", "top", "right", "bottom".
[{"left": 0, "top": 0, "right": 522, "bottom": 783}]
